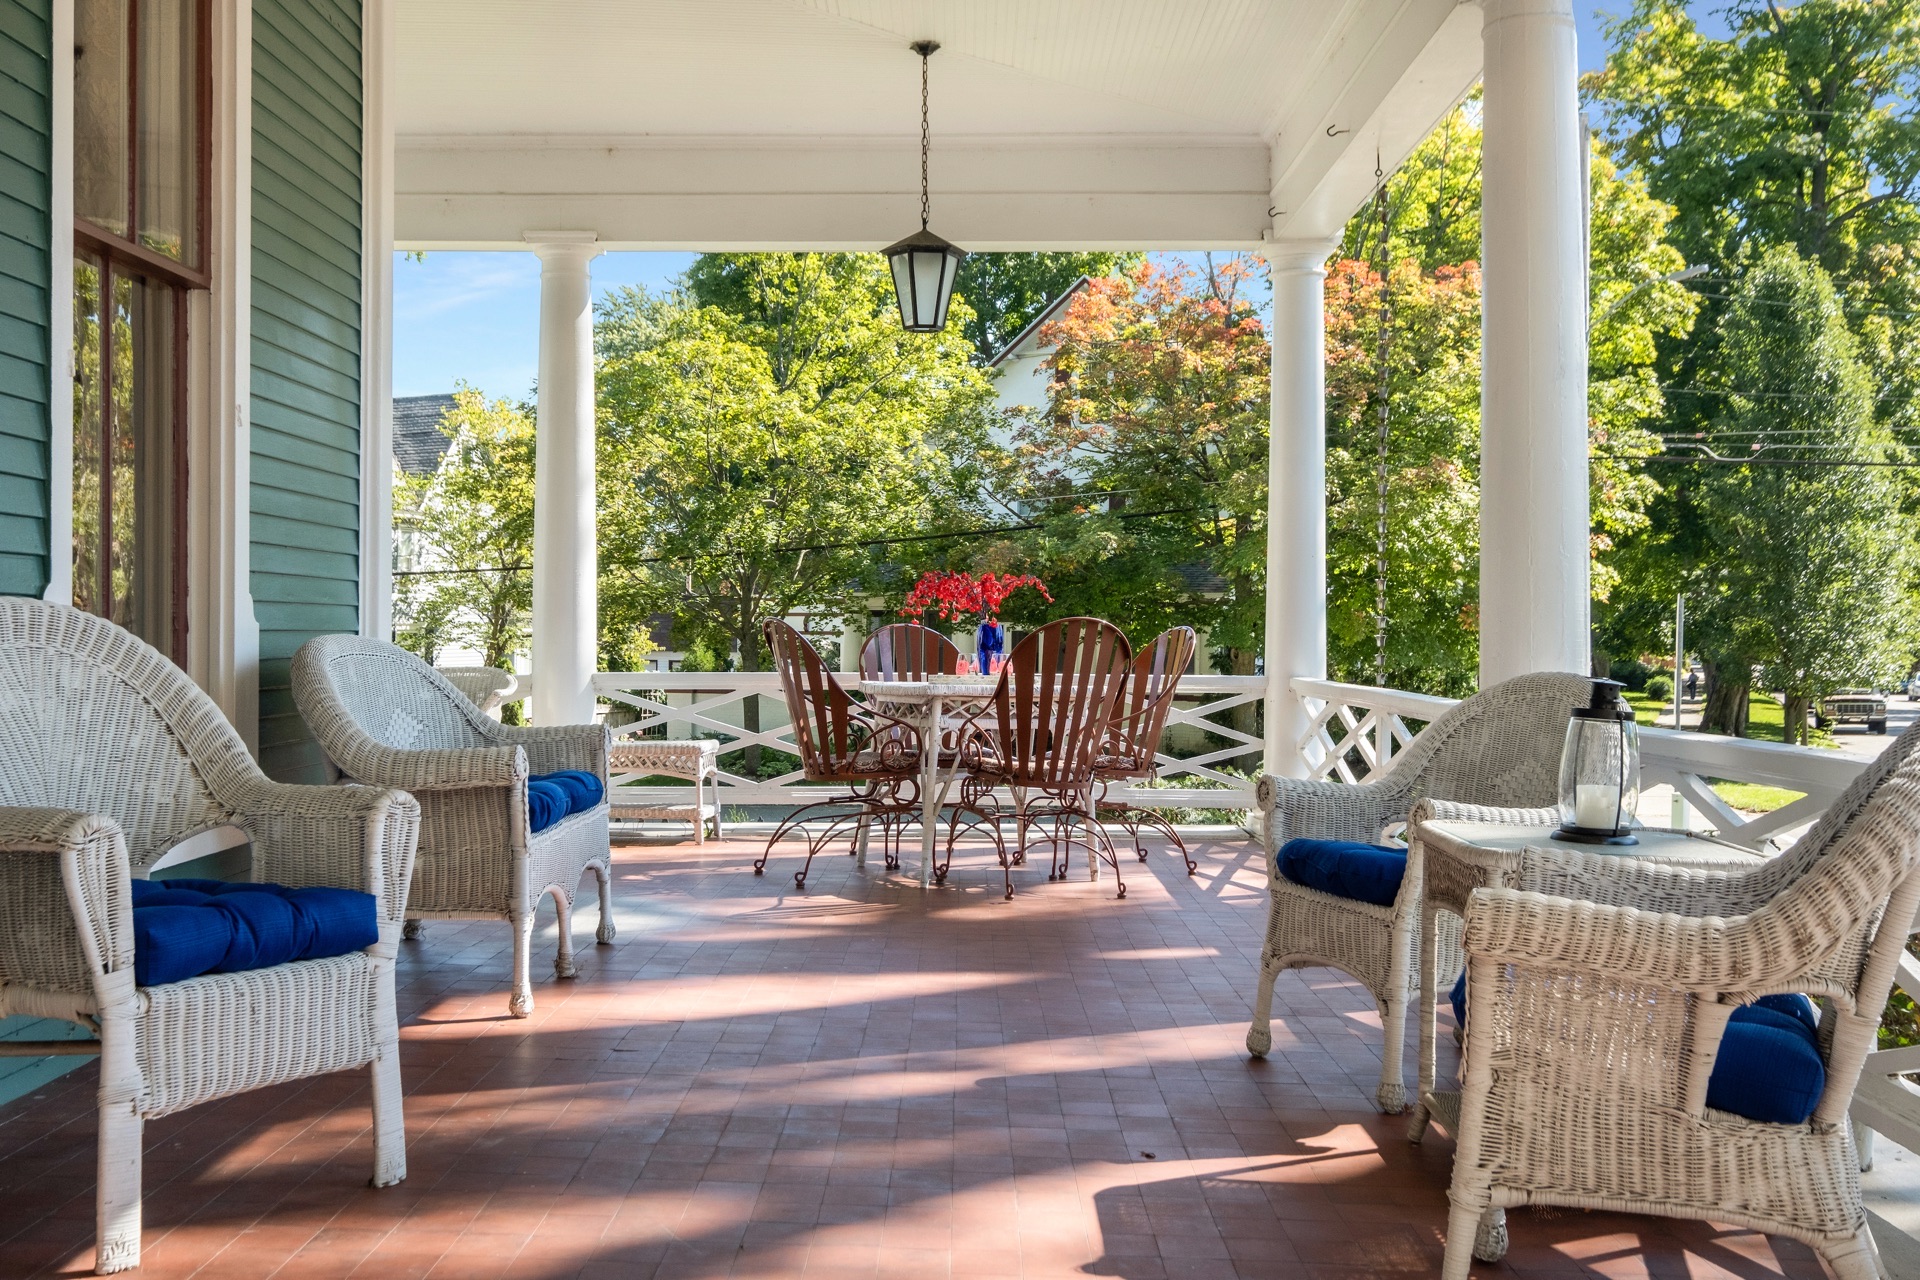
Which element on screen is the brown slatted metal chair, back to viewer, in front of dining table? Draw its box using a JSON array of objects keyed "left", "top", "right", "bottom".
[{"left": 947, "top": 618, "right": 1133, "bottom": 898}]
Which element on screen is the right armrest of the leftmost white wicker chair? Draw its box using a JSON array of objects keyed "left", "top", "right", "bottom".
[{"left": 222, "top": 781, "right": 420, "bottom": 923}]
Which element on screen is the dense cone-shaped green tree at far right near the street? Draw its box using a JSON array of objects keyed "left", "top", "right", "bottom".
[{"left": 1692, "top": 246, "right": 1912, "bottom": 741}]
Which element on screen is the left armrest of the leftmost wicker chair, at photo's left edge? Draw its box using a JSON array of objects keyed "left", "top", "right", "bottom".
[{"left": 0, "top": 806, "right": 132, "bottom": 996}]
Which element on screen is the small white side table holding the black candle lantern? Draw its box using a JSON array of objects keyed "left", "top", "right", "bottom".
[{"left": 1407, "top": 819, "right": 1764, "bottom": 1142}]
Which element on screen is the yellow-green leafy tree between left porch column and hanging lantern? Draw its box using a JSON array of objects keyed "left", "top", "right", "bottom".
[{"left": 599, "top": 253, "right": 991, "bottom": 670}]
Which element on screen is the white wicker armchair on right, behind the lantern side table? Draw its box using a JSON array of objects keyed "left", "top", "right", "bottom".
[{"left": 1246, "top": 674, "right": 1594, "bottom": 1115}]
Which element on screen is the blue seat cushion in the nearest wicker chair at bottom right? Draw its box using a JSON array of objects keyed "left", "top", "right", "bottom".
[{"left": 1452, "top": 973, "right": 1826, "bottom": 1125}]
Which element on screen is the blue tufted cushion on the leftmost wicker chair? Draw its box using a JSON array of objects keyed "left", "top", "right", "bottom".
[{"left": 132, "top": 881, "right": 380, "bottom": 986}]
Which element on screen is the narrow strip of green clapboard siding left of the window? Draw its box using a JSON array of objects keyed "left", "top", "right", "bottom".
[{"left": 0, "top": 0, "right": 54, "bottom": 595}]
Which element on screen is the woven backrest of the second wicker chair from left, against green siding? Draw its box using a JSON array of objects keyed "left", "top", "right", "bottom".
[{"left": 309, "top": 635, "right": 495, "bottom": 750}]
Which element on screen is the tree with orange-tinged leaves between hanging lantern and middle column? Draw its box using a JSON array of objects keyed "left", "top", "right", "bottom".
[{"left": 1004, "top": 257, "right": 1271, "bottom": 674}]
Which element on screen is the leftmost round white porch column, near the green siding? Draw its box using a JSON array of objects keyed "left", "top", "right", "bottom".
[{"left": 526, "top": 230, "right": 599, "bottom": 725}]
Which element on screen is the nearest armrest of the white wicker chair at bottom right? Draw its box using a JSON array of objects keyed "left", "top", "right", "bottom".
[{"left": 1461, "top": 889, "right": 1781, "bottom": 998}]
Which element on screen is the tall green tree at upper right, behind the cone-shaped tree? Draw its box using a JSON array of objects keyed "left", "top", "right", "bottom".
[{"left": 1586, "top": 0, "right": 1920, "bottom": 710}]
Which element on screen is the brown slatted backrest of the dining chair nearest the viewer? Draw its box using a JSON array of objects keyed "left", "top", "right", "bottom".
[{"left": 989, "top": 618, "right": 1133, "bottom": 793}]
